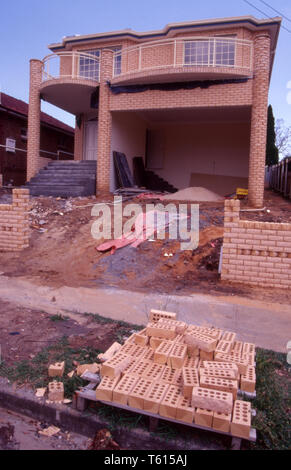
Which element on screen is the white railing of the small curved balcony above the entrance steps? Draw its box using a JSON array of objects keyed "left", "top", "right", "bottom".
[{"left": 42, "top": 51, "right": 100, "bottom": 82}]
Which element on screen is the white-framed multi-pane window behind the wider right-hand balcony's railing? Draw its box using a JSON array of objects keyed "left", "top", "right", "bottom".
[{"left": 184, "top": 37, "right": 235, "bottom": 66}]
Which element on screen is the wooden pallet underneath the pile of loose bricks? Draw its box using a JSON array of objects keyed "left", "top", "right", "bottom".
[{"left": 73, "top": 383, "right": 257, "bottom": 449}]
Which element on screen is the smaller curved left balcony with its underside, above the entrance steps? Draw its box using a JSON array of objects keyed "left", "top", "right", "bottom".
[{"left": 40, "top": 51, "right": 100, "bottom": 115}]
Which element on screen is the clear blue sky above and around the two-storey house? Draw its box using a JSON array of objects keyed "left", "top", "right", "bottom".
[{"left": 0, "top": 0, "right": 291, "bottom": 126}]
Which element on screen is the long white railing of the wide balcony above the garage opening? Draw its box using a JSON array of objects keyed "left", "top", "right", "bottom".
[{"left": 113, "top": 36, "right": 253, "bottom": 77}]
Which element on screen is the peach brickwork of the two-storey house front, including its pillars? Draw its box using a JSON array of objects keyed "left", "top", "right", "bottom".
[{"left": 30, "top": 17, "right": 279, "bottom": 207}]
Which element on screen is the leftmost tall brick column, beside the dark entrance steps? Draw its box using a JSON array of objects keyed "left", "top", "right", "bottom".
[{"left": 26, "top": 59, "right": 42, "bottom": 180}]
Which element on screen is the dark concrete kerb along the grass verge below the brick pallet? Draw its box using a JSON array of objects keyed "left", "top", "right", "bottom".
[{"left": 0, "top": 377, "right": 227, "bottom": 450}]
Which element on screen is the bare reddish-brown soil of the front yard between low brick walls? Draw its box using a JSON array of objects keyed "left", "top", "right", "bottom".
[{"left": 0, "top": 190, "right": 291, "bottom": 304}]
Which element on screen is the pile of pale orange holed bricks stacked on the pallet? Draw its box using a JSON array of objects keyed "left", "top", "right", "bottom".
[{"left": 96, "top": 311, "right": 256, "bottom": 438}]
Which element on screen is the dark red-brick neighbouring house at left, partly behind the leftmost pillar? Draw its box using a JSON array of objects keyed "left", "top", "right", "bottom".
[{"left": 0, "top": 93, "right": 74, "bottom": 186}]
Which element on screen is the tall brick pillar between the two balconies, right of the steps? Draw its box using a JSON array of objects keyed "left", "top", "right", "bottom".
[{"left": 96, "top": 49, "right": 113, "bottom": 192}]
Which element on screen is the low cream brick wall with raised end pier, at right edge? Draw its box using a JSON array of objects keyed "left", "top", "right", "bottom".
[{"left": 221, "top": 200, "right": 291, "bottom": 288}]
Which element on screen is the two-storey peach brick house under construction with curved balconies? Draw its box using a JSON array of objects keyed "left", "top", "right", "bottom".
[{"left": 27, "top": 16, "right": 281, "bottom": 207}]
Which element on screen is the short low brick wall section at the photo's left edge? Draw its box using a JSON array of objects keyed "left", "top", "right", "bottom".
[{"left": 0, "top": 189, "right": 29, "bottom": 251}]
